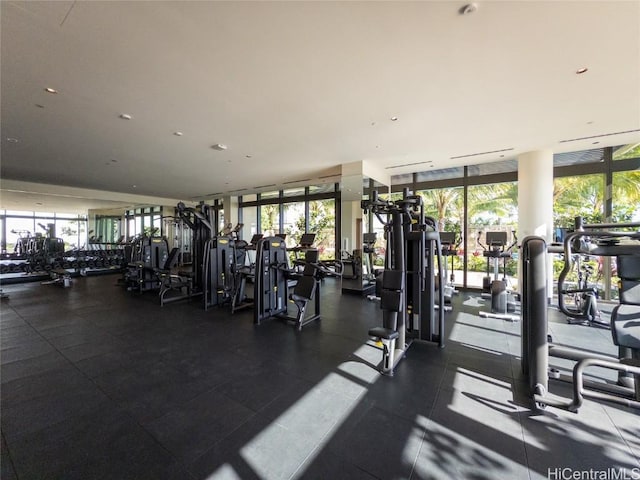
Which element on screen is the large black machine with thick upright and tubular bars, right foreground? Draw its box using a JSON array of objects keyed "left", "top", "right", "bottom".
[{"left": 521, "top": 230, "right": 640, "bottom": 412}]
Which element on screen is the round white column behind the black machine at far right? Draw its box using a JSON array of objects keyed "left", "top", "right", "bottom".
[{"left": 518, "top": 150, "right": 553, "bottom": 296}]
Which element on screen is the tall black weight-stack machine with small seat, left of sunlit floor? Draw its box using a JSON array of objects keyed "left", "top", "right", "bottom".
[{"left": 361, "top": 189, "right": 445, "bottom": 375}]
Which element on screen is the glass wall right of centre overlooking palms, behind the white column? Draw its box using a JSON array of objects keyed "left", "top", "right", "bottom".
[{"left": 388, "top": 144, "right": 640, "bottom": 295}]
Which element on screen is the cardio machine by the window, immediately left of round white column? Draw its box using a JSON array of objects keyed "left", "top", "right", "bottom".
[{"left": 478, "top": 231, "right": 519, "bottom": 322}]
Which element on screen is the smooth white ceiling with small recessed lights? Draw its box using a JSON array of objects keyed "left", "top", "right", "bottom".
[{"left": 0, "top": 0, "right": 640, "bottom": 209}]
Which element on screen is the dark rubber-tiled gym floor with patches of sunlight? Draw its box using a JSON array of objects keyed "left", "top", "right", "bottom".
[{"left": 1, "top": 275, "right": 640, "bottom": 480}]
